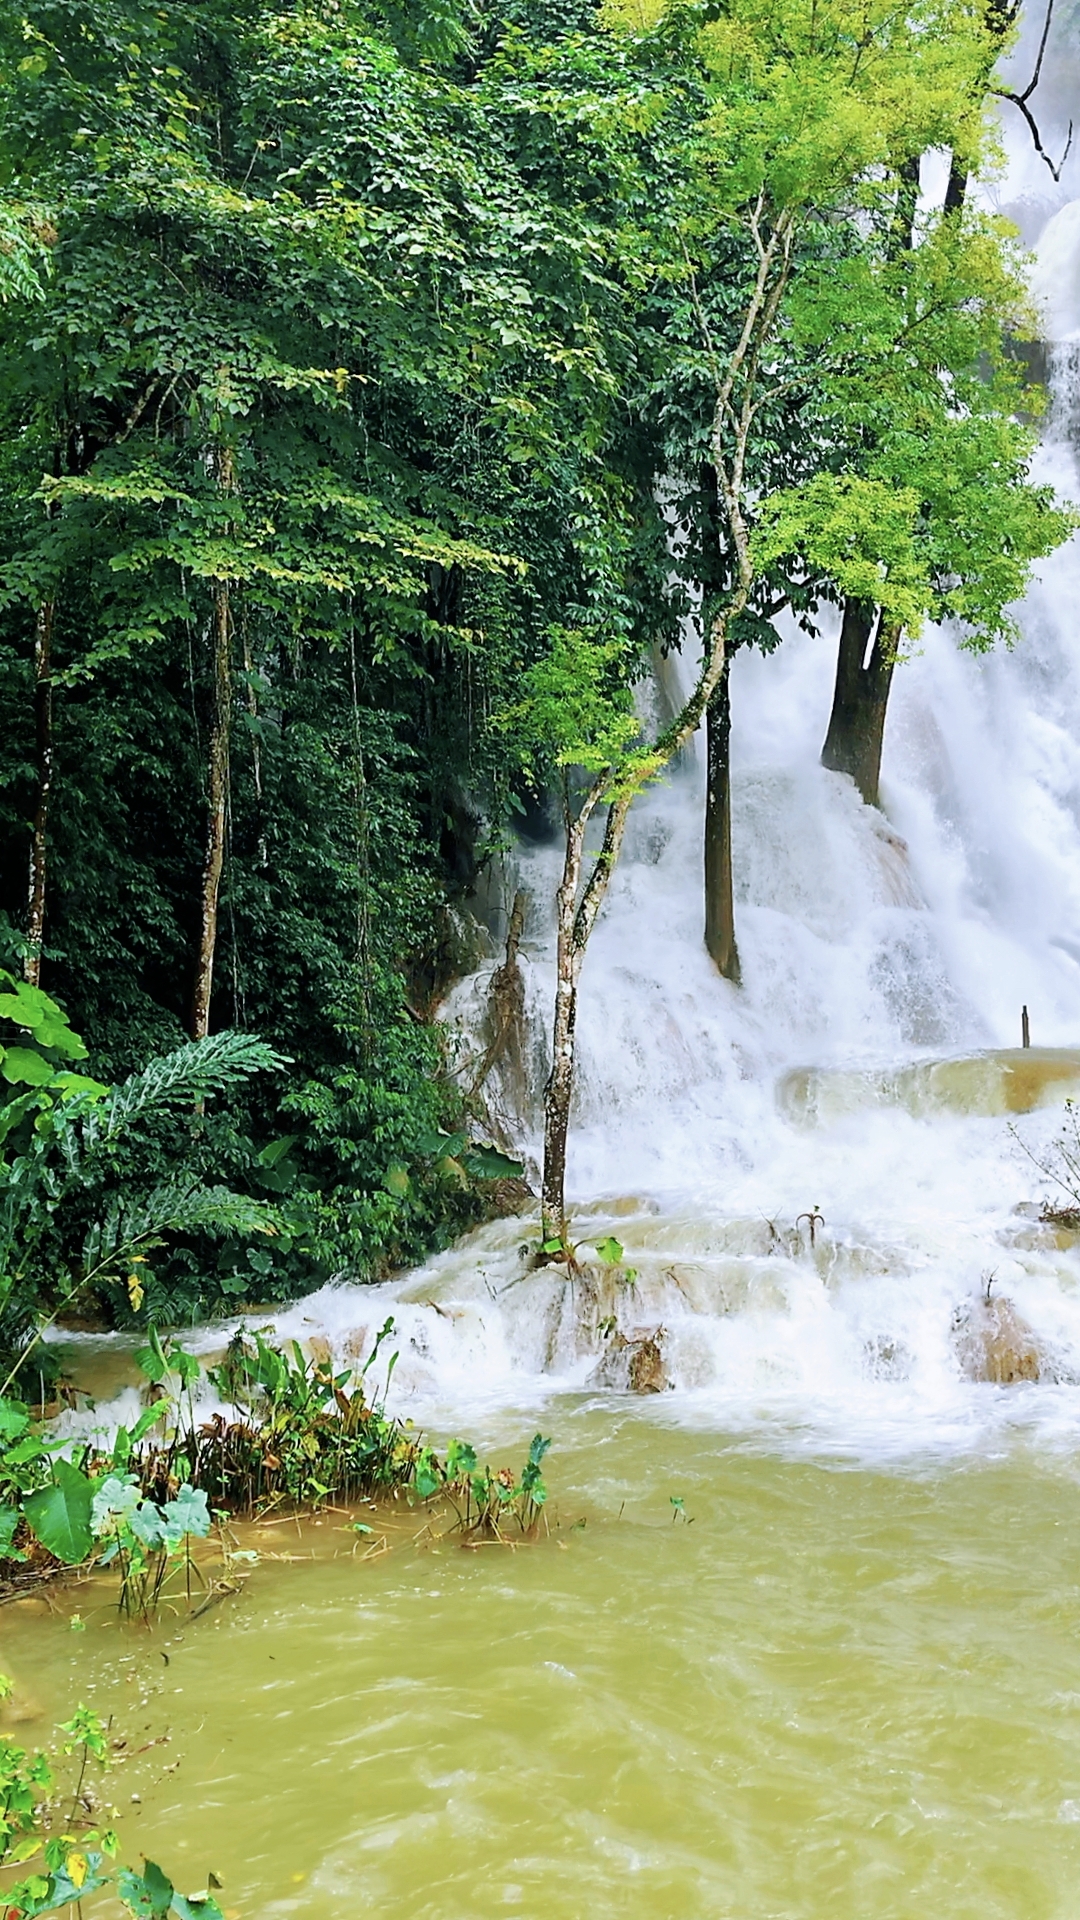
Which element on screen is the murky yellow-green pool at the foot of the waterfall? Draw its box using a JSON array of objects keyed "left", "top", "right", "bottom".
[{"left": 0, "top": 1402, "right": 1080, "bottom": 1920}]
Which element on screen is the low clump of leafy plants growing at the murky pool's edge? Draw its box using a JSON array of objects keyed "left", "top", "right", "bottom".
[{"left": 0, "top": 1319, "right": 552, "bottom": 1624}]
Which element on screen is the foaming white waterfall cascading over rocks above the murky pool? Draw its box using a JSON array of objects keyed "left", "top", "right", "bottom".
[{"left": 56, "top": 183, "right": 1080, "bottom": 1453}]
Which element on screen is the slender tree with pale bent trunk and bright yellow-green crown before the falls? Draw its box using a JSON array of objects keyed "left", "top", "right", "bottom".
[{"left": 507, "top": 0, "right": 1070, "bottom": 1248}]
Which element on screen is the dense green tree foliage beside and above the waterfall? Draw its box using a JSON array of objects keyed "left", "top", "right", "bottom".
[{"left": 0, "top": 0, "right": 1067, "bottom": 1321}]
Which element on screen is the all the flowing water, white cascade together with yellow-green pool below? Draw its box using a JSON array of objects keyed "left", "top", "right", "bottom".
[{"left": 10, "top": 161, "right": 1080, "bottom": 1920}]
